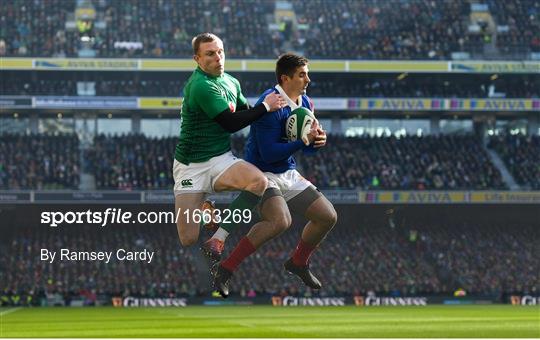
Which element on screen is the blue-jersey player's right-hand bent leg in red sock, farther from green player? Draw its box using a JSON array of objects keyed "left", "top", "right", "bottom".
[{"left": 284, "top": 186, "right": 337, "bottom": 289}]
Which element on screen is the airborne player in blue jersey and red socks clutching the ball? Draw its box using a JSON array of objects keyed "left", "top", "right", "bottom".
[{"left": 214, "top": 53, "right": 337, "bottom": 297}]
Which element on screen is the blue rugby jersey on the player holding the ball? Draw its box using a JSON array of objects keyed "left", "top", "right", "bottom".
[{"left": 244, "top": 87, "right": 317, "bottom": 173}]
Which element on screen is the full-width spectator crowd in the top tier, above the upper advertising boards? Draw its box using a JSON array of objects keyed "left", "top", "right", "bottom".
[{"left": 0, "top": 0, "right": 540, "bottom": 59}]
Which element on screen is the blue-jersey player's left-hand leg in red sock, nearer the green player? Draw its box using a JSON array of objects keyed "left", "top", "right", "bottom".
[{"left": 214, "top": 188, "right": 291, "bottom": 297}]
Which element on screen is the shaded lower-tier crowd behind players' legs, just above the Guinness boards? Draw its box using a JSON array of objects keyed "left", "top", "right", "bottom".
[{"left": 0, "top": 209, "right": 540, "bottom": 304}]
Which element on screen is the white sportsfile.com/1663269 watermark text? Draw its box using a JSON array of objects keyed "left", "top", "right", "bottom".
[{"left": 40, "top": 208, "right": 252, "bottom": 227}]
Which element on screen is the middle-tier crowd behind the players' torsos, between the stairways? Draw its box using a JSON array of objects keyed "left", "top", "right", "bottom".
[{"left": 86, "top": 135, "right": 505, "bottom": 190}]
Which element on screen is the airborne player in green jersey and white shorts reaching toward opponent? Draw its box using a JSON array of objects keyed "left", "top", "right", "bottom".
[{"left": 173, "top": 33, "right": 286, "bottom": 270}]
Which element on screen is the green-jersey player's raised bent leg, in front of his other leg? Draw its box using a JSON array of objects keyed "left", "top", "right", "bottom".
[{"left": 201, "top": 158, "right": 268, "bottom": 265}]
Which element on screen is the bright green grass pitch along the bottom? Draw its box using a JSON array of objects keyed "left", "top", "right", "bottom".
[{"left": 0, "top": 305, "right": 540, "bottom": 338}]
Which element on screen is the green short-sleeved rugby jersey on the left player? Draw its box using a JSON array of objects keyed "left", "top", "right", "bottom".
[{"left": 174, "top": 67, "right": 247, "bottom": 164}]
